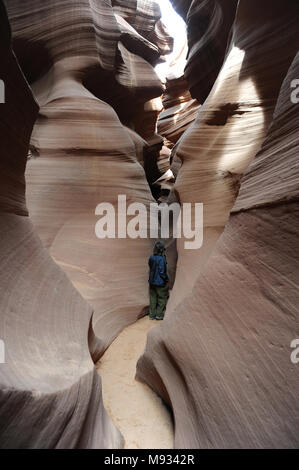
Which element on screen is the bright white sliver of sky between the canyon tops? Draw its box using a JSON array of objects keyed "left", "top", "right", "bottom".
[{"left": 156, "top": 0, "right": 187, "bottom": 82}]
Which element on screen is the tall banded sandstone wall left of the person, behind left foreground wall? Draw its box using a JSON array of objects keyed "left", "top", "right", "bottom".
[{"left": 6, "top": 0, "right": 172, "bottom": 357}]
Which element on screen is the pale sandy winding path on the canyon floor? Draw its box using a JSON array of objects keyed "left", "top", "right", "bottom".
[{"left": 97, "top": 316, "right": 173, "bottom": 449}]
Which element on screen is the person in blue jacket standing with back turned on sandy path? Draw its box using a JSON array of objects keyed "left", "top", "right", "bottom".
[{"left": 148, "top": 241, "right": 169, "bottom": 320}]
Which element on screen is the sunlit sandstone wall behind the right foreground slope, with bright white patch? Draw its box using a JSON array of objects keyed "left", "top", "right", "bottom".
[{"left": 171, "top": 0, "right": 299, "bottom": 306}]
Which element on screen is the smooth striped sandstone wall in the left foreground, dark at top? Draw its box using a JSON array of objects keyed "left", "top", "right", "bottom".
[{"left": 0, "top": 1, "right": 122, "bottom": 448}]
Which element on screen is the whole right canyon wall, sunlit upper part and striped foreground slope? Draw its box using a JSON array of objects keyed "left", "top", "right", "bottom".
[{"left": 137, "top": 0, "right": 299, "bottom": 448}]
